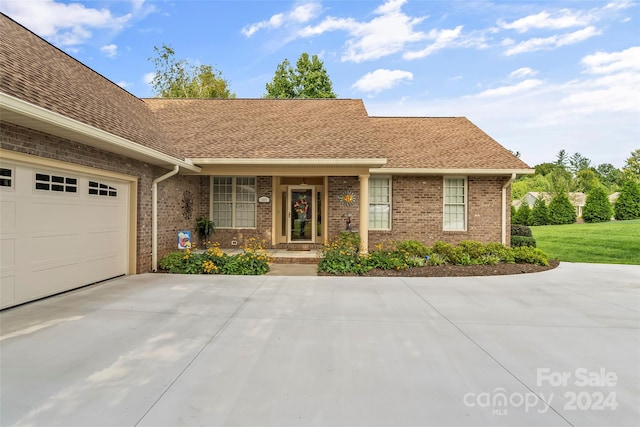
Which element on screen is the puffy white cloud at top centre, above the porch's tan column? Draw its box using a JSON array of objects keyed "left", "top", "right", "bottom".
[{"left": 298, "top": 0, "right": 427, "bottom": 62}]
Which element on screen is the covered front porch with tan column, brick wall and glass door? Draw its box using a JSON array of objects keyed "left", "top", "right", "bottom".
[{"left": 182, "top": 159, "right": 386, "bottom": 252}]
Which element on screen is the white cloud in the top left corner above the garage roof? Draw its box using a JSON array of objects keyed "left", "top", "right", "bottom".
[{"left": 2, "top": 0, "right": 133, "bottom": 48}]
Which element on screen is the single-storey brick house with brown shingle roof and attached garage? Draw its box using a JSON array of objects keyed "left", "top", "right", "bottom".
[{"left": 0, "top": 15, "right": 532, "bottom": 307}]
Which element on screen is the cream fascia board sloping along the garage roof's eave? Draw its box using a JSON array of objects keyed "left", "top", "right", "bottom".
[{"left": 0, "top": 92, "right": 200, "bottom": 172}]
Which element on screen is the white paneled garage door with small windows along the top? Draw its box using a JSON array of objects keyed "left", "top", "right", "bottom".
[{"left": 0, "top": 161, "right": 129, "bottom": 308}]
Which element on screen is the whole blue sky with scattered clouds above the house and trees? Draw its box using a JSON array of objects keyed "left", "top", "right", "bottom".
[{"left": 0, "top": 0, "right": 640, "bottom": 167}]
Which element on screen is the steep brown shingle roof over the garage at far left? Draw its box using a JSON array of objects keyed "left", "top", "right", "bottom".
[{"left": 0, "top": 14, "right": 181, "bottom": 158}]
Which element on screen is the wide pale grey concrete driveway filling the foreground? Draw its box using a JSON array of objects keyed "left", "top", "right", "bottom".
[{"left": 0, "top": 263, "right": 640, "bottom": 427}]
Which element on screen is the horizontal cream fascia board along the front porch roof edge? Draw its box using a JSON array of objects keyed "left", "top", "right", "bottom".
[{"left": 187, "top": 157, "right": 387, "bottom": 168}]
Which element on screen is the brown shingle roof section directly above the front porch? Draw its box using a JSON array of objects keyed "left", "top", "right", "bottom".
[{"left": 145, "top": 98, "right": 384, "bottom": 159}]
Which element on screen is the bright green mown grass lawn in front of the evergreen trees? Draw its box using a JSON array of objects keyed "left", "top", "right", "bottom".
[{"left": 531, "top": 219, "right": 640, "bottom": 264}]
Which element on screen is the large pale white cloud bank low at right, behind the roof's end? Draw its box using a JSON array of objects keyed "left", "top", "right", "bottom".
[{"left": 367, "top": 47, "right": 640, "bottom": 167}]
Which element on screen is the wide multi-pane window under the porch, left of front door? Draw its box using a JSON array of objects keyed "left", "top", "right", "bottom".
[{"left": 211, "top": 176, "right": 257, "bottom": 228}]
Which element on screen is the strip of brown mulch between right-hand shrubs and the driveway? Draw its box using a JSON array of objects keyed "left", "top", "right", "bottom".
[{"left": 318, "top": 259, "right": 560, "bottom": 277}]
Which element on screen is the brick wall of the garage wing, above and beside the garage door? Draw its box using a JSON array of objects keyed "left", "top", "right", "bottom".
[{"left": 0, "top": 122, "right": 202, "bottom": 273}]
